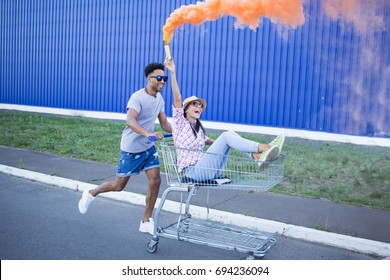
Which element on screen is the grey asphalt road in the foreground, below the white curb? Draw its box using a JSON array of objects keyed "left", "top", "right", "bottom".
[{"left": 0, "top": 173, "right": 375, "bottom": 260}]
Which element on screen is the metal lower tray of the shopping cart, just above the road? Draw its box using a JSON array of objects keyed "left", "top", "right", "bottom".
[{"left": 159, "top": 217, "right": 276, "bottom": 258}]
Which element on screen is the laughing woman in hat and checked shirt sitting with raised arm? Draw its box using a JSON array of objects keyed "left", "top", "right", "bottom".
[{"left": 165, "top": 59, "right": 284, "bottom": 182}]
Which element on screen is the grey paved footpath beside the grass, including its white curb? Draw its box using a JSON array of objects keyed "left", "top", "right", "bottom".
[{"left": 0, "top": 146, "right": 390, "bottom": 257}]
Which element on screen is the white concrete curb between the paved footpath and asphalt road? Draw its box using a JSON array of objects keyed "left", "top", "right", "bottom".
[{"left": 0, "top": 164, "right": 390, "bottom": 258}]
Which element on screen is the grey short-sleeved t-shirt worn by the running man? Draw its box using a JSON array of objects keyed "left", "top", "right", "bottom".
[{"left": 121, "top": 88, "right": 165, "bottom": 153}]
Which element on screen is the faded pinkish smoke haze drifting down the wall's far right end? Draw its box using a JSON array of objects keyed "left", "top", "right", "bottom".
[{"left": 322, "top": 0, "right": 390, "bottom": 136}]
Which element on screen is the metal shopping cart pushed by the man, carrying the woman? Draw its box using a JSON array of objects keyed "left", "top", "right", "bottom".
[{"left": 146, "top": 135, "right": 285, "bottom": 259}]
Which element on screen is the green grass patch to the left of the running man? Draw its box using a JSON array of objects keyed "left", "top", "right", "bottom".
[{"left": 0, "top": 111, "right": 123, "bottom": 163}]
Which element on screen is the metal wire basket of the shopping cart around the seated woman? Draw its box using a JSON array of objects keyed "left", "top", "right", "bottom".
[{"left": 159, "top": 140, "right": 285, "bottom": 191}]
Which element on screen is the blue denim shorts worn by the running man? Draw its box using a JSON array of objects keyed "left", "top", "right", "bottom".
[{"left": 116, "top": 146, "right": 160, "bottom": 178}]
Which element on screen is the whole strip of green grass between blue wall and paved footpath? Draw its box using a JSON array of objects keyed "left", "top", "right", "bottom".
[{"left": 0, "top": 111, "right": 390, "bottom": 210}]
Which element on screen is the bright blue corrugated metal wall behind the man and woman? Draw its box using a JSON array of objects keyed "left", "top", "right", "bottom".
[{"left": 0, "top": 0, "right": 390, "bottom": 137}]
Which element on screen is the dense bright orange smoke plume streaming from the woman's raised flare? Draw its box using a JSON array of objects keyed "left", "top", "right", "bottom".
[{"left": 163, "top": 0, "right": 305, "bottom": 44}]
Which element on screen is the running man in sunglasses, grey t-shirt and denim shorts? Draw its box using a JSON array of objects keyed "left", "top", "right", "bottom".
[{"left": 79, "top": 63, "right": 172, "bottom": 234}]
